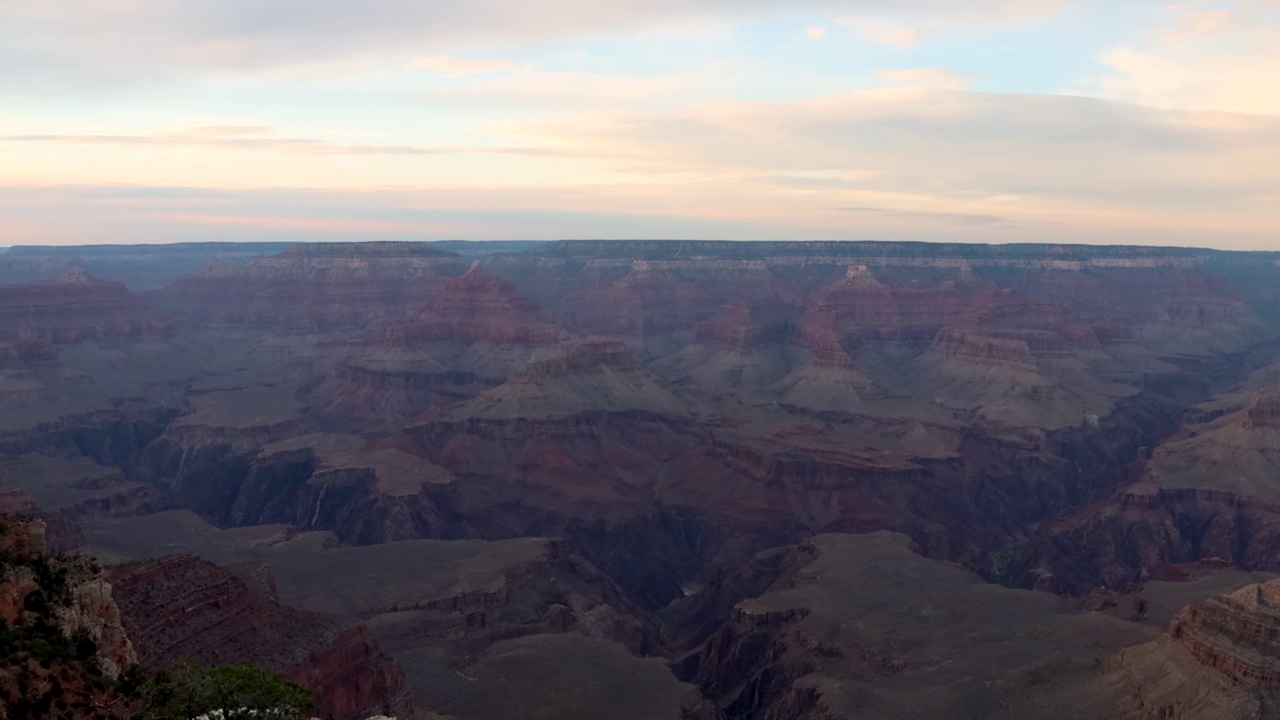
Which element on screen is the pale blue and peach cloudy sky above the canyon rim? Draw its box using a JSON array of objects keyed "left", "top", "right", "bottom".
[{"left": 0, "top": 0, "right": 1280, "bottom": 250}]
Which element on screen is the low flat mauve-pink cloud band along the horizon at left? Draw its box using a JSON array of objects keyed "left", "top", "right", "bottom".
[{"left": 0, "top": 186, "right": 788, "bottom": 246}]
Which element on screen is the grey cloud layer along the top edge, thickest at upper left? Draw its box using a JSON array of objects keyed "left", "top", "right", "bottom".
[{"left": 0, "top": 0, "right": 1060, "bottom": 87}]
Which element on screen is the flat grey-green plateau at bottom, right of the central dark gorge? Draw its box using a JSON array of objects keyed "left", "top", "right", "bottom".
[{"left": 677, "top": 533, "right": 1153, "bottom": 720}]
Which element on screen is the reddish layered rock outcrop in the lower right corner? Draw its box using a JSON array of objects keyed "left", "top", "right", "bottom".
[{"left": 1169, "top": 580, "right": 1280, "bottom": 688}]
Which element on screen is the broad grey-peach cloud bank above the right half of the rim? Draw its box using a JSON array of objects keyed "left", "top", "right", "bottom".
[{"left": 499, "top": 88, "right": 1280, "bottom": 243}]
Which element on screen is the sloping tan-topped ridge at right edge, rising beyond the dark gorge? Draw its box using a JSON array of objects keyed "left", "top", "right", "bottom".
[{"left": 1020, "top": 368, "right": 1280, "bottom": 592}]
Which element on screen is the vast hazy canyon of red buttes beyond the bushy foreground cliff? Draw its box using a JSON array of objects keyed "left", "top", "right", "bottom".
[{"left": 0, "top": 241, "right": 1280, "bottom": 720}]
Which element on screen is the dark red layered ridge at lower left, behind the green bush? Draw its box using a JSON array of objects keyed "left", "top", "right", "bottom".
[{"left": 110, "top": 555, "right": 410, "bottom": 720}]
